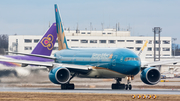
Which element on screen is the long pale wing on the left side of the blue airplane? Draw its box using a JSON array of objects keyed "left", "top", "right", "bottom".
[{"left": 0, "top": 59, "right": 93, "bottom": 73}]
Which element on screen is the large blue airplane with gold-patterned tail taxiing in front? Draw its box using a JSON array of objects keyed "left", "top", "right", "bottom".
[{"left": 0, "top": 4, "right": 169, "bottom": 90}]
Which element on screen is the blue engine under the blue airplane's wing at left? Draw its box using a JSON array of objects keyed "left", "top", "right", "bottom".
[{"left": 49, "top": 67, "right": 71, "bottom": 84}]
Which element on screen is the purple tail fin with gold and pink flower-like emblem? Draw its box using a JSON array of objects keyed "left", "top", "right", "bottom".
[{"left": 31, "top": 23, "right": 57, "bottom": 56}]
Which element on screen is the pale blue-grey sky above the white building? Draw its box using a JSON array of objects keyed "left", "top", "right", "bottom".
[{"left": 0, "top": 0, "right": 180, "bottom": 44}]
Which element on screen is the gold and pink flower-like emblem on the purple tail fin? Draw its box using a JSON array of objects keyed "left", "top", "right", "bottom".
[{"left": 41, "top": 34, "right": 54, "bottom": 50}]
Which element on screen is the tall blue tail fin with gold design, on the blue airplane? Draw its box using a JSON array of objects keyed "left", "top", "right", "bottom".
[{"left": 54, "top": 4, "right": 68, "bottom": 50}]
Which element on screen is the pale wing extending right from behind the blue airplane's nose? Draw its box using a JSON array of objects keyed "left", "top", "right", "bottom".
[{"left": 142, "top": 59, "right": 180, "bottom": 67}]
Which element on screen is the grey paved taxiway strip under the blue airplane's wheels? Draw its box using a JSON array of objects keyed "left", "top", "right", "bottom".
[{"left": 0, "top": 88, "right": 180, "bottom": 95}]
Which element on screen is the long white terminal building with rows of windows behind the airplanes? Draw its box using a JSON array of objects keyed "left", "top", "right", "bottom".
[{"left": 9, "top": 29, "right": 171, "bottom": 61}]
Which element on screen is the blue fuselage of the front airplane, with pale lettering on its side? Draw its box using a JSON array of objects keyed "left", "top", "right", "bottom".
[{"left": 54, "top": 48, "right": 141, "bottom": 78}]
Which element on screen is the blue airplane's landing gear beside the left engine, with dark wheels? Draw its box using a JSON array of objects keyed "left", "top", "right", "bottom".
[{"left": 61, "top": 73, "right": 76, "bottom": 90}]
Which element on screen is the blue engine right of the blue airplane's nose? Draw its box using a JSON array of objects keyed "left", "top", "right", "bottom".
[{"left": 141, "top": 67, "right": 161, "bottom": 85}]
